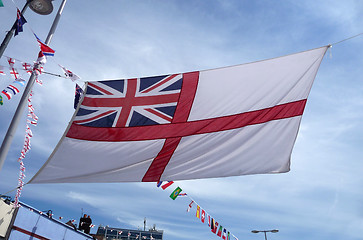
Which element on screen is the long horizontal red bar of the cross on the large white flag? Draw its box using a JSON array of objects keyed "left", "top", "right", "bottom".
[{"left": 67, "top": 99, "right": 306, "bottom": 142}]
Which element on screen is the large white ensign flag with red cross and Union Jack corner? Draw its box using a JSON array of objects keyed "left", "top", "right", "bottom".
[{"left": 29, "top": 46, "right": 329, "bottom": 183}]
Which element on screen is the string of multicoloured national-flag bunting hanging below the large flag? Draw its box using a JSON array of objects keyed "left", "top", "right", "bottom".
[{"left": 157, "top": 181, "right": 238, "bottom": 240}]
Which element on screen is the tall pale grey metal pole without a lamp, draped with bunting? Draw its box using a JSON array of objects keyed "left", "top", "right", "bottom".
[{"left": 0, "top": 0, "right": 67, "bottom": 171}]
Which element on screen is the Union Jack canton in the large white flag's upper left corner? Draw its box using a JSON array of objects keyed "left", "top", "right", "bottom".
[{"left": 74, "top": 74, "right": 183, "bottom": 127}]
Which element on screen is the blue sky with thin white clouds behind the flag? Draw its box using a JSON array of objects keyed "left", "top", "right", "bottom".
[{"left": 0, "top": 0, "right": 363, "bottom": 240}]
